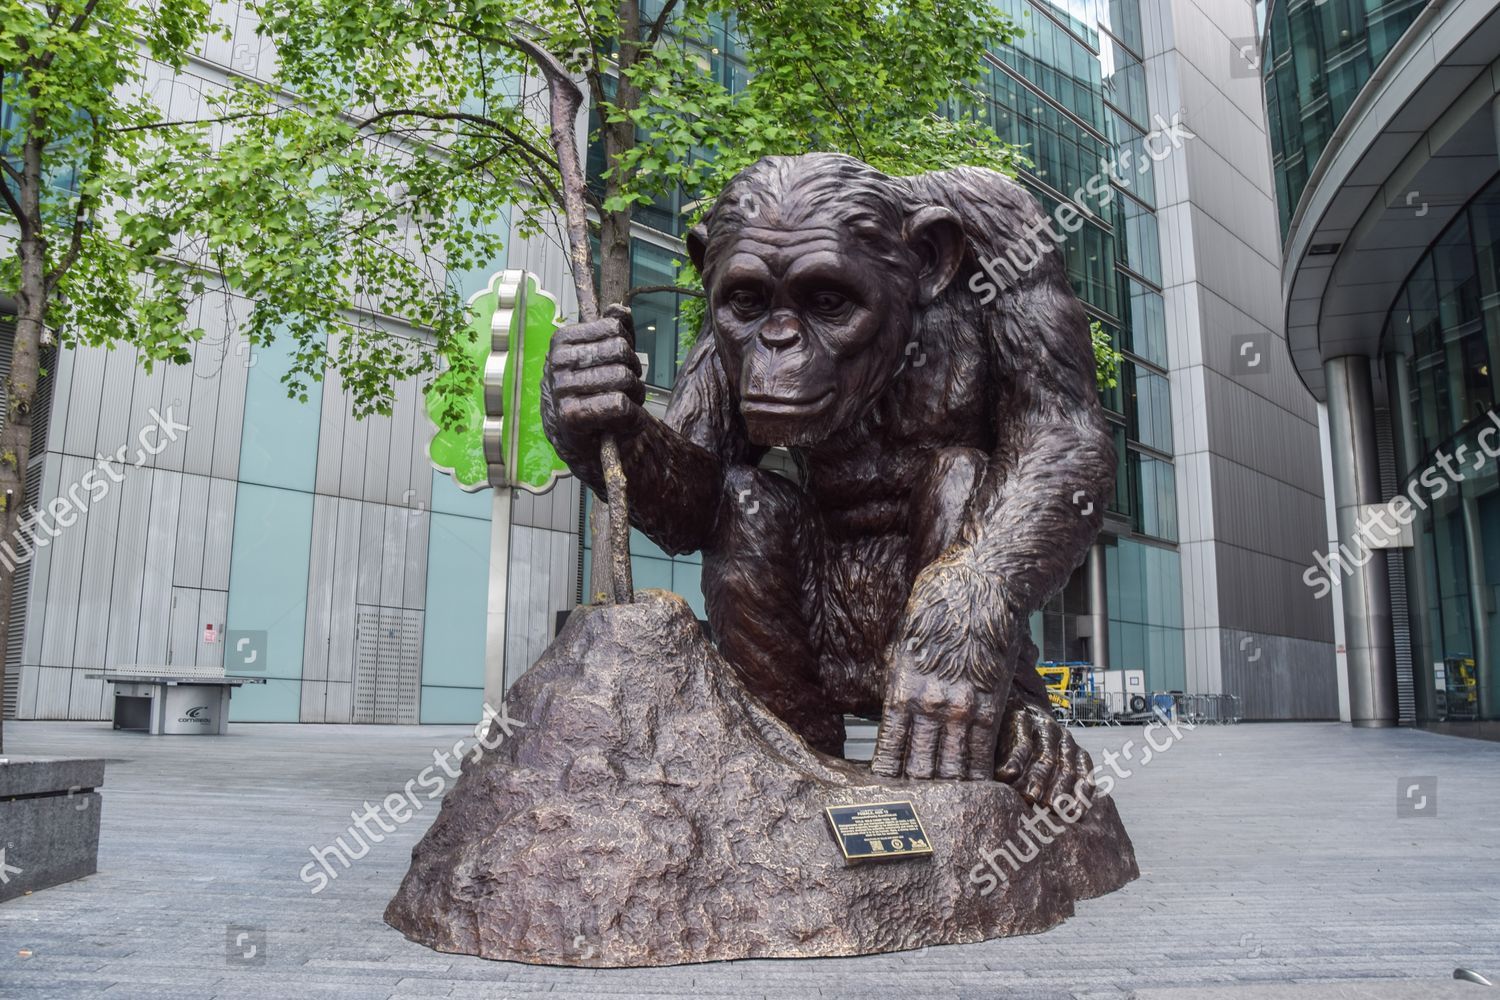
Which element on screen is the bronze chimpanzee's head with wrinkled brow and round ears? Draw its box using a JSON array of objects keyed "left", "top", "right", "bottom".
[{"left": 687, "top": 153, "right": 965, "bottom": 445}]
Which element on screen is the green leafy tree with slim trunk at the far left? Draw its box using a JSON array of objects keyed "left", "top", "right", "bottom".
[{"left": 0, "top": 0, "right": 231, "bottom": 748}]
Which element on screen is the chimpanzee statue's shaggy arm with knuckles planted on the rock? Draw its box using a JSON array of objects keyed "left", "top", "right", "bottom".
[{"left": 873, "top": 293, "right": 1115, "bottom": 778}]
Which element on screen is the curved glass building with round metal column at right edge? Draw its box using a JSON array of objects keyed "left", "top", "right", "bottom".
[{"left": 1260, "top": 0, "right": 1500, "bottom": 732}]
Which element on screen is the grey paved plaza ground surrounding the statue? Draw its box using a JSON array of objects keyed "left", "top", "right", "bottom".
[{"left": 0, "top": 723, "right": 1500, "bottom": 1000}]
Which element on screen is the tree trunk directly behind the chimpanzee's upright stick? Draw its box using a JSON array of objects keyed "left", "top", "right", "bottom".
[{"left": 588, "top": 0, "right": 641, "bottom": 601}]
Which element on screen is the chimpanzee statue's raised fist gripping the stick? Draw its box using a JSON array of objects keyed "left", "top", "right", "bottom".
[{"left": 542, "top": 306, "right": 647, "bottom": 459}]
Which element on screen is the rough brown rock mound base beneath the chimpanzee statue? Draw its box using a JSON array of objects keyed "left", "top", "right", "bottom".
[{"left": 386, "top": 591, "right": 1139, "bottom": 967}]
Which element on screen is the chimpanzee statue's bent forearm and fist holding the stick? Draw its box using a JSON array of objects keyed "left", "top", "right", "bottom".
[{"left": 542, "top": 309, "right": 746, "bottom": 555}]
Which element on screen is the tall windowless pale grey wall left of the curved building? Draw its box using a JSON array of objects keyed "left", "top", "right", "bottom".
[{"left": 1142, "top": 0, "right": 1338, "bottom": 718}]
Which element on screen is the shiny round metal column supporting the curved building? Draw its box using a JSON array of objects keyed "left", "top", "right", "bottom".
[{"left": 1323, "top": 354, "right": 1398, "bottom": 727}]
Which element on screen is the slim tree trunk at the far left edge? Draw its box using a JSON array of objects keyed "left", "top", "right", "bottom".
[{"left": 0, "top": 138, "right": 47, "bottom": 751}]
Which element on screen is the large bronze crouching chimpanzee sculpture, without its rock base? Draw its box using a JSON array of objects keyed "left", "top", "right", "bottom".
[{"left": 542, "top": 154, "right": 1115, "bottom": 802}]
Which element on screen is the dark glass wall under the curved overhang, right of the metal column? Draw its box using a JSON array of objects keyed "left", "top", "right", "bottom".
[{"left": 1382, "top": 177, "right": 1500, "bottom": 723}]
